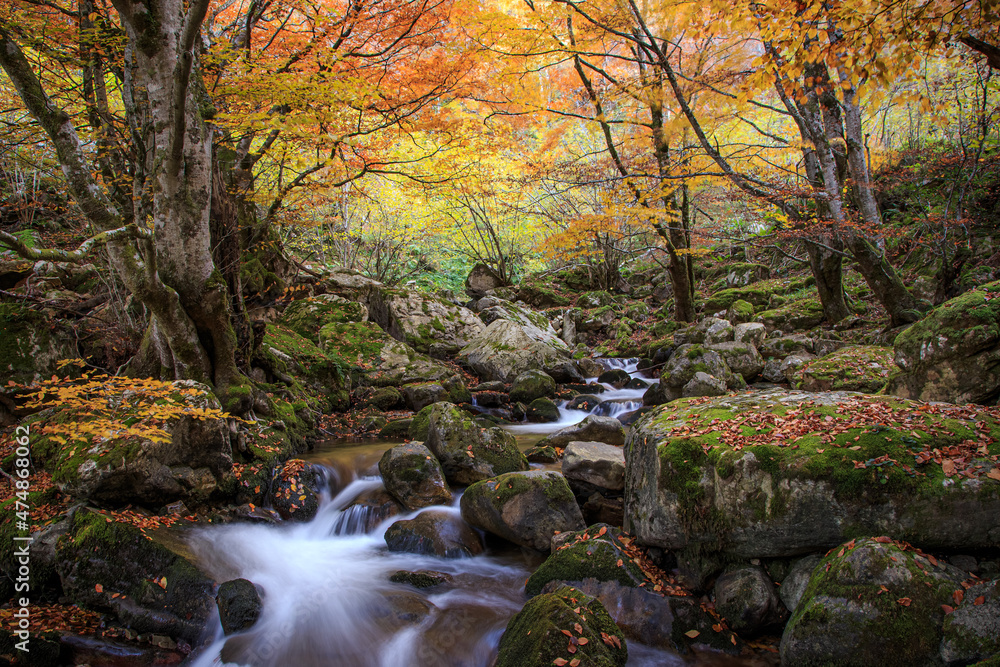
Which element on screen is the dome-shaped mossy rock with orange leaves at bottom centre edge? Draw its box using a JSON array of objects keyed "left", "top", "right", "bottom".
[{"left": 496, "top": 587, "right": 628, "bottom": 667}]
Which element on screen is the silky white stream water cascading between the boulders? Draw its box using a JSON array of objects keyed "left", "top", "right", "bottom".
[{"left": 190, "top": 360, "right": 704, "bottom": 667}]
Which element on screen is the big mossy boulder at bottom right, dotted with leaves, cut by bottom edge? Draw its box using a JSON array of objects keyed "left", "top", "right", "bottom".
[{"left": 781, "top": 538, "right": 964, "bottom": 667}]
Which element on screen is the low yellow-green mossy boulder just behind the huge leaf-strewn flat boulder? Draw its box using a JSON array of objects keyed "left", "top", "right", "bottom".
[{"left": 793, "top": 345, "right": 895, "bottom": 394}]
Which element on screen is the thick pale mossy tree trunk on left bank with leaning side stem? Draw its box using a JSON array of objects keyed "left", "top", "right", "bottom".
[{"left": 0, "top": 0, "right": 250, "bottom": 412}]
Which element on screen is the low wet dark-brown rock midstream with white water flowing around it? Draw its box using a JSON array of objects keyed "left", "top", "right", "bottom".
[{"left": 385, "top": 510, "right": 483, "bottom": 558}]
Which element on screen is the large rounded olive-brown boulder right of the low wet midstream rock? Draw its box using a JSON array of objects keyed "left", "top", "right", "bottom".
[{"left": 461, "top": 470, "right": 585, "bottom": 551}]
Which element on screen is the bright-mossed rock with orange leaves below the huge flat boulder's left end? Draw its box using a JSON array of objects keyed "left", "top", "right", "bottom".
[{"left": 524, "top": 524, "right": 646, "bottom": 596}]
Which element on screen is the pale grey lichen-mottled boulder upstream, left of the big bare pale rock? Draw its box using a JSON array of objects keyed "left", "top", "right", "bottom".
[{"left": 368, "top": 287, "right": 485, "bottom": 356}]
